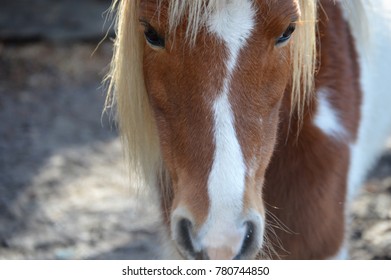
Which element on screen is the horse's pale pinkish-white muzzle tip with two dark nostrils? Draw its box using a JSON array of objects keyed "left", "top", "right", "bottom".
[{"left": 171, "top": 209, "right": 263, "bottom": 260}]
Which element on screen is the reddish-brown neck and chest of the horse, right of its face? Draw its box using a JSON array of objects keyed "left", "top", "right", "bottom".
[{"left": 263, "top": 1, "right": 362, "bottom": 259}]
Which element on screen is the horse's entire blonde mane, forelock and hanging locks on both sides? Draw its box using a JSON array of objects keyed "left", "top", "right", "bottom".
[{"left": 106, "top": 0, "right": 360, "bottom": 188}]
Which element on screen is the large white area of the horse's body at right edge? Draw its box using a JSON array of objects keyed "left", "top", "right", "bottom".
[{"left": 344, "top": 0, "right": 391, "bottom": 198}]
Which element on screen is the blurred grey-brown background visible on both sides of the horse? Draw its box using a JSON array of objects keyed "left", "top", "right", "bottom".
[{"left": 0, "top": 0, "right": 391, "bottom": 259}]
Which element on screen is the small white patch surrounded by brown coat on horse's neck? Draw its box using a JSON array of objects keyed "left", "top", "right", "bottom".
[{"left": 314, "top": 89, "right": 347, "bottom": 140}]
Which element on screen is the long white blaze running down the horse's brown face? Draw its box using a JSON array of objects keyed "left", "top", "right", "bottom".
[{"left": 200, "top": 0, "right": 255, "bottom": 253}]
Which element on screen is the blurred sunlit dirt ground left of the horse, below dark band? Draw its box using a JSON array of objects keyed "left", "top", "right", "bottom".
[{"left": 0, "top": 44, "right": 162, "bottom": 259}]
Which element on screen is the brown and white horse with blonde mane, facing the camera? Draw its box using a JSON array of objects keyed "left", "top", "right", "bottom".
[{"left": 106, "top": 0, "right": 391, "bottom": 259}]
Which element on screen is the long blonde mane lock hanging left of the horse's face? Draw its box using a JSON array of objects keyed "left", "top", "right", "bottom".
[{"left": 106, "top": 0, "right": 161, "bottom": 190}]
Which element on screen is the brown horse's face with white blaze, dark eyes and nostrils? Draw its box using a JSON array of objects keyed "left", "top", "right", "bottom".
[{"left": 140, "top": 0, "right": 298, "bottom": 259}]
